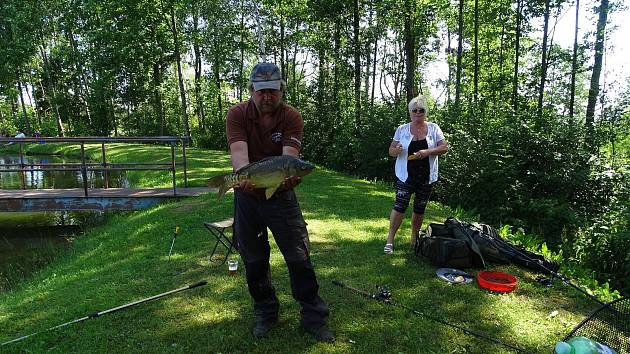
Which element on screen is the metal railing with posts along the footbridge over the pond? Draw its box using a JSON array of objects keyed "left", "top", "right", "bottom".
[{"left": 0, "top": 136, "right": 190, "bottom": 197}]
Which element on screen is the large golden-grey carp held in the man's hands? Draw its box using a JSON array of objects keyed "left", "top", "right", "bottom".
[{"left": 207, "top": 155, "right": 315, "bottom": 199}]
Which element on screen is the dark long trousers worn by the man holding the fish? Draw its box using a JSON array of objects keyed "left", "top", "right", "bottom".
[{"left": 234, "top": 189, "right": 329, "bottom": 328}]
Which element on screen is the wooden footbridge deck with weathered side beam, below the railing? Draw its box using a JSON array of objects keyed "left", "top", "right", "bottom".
[{"left": 0, "top": 187, "right": 216, "bottom": 212}]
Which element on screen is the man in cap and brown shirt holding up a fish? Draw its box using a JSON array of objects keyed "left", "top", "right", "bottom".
[{"left": 226, "top": 63, "right": 335, "bottom": 342}]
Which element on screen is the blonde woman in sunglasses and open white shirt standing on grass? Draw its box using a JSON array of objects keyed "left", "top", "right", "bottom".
[{"left": 384, "top": 96, "right": 448, "bottom": 254}]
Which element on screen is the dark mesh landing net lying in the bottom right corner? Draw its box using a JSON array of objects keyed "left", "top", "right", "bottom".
[{"left": 564, "top": 298, "right": 630, "bottom": 354}]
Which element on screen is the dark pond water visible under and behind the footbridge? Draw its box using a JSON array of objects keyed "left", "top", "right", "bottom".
[{"left": 0, "top": 156, "right": 129, "bottom": 291}]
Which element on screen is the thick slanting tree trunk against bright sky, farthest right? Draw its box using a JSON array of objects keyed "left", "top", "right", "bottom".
[{"left": 586, "top": 0, "right": 608, "bottom": 136}]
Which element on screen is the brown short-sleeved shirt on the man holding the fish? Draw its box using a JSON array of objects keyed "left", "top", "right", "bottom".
[{"left": 225, "top": 99, "right": 304, "bottom": 162}]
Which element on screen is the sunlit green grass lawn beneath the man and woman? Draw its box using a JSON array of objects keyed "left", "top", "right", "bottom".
[{"left": 0, "top": 144, "right": 595, "bottom": 353}]
